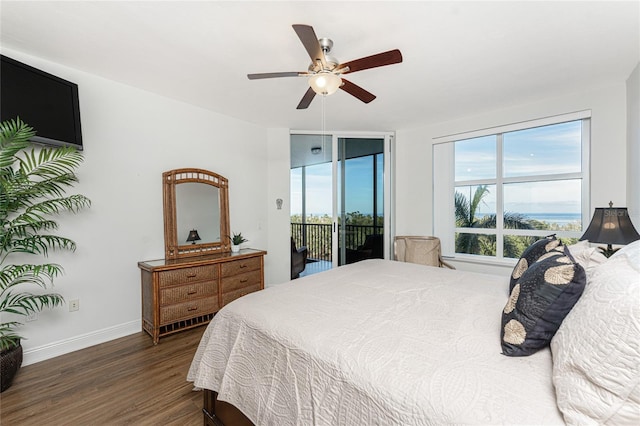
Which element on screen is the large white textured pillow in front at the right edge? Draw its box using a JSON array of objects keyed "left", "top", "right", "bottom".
[{"left": 551, "top": 255, "right": 640, "bottom": 425}]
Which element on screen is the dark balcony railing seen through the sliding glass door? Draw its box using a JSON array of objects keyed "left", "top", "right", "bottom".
[{"left": 291, "top": 222, "right": 383, "bottom": 261}]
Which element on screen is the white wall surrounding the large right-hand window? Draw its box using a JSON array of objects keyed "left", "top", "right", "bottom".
[{"left": 396, "top": 81, "right": 627, "bottom": 275}]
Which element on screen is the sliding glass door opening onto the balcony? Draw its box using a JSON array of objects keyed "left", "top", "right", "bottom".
[{"left": 291, "top": 133, "right": 392, "bottom": 275}]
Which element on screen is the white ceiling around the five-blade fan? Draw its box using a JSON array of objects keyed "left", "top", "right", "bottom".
[{"left": 0, "top": 0, "right": 640, "bottom": 131}]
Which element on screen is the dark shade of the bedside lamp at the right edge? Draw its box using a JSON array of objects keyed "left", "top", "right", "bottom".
[{"left": 580, "top": 207, "right": 640, "bottom": 245}]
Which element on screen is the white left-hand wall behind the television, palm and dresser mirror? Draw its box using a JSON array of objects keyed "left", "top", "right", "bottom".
[{"left": 3, "top": 49, "right": 270, "bottom": 365}]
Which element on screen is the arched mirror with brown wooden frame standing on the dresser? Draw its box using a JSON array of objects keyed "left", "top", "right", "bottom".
[{"left": 162, "top": 169, "right": 231, "bottom": 259}]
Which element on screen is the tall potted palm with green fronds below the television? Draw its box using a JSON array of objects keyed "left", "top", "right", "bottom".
[{"left": 0, "top": 119, "right": 91, "bottom": 391}]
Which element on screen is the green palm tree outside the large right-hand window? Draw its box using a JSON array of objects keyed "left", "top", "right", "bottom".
[{"left": 454, "top": 185, "right": 534, "bottom": 257}]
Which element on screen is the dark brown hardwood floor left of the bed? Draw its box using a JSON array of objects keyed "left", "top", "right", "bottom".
[{"left": 0, "top": 327, "right": 205, "bottom": 426}]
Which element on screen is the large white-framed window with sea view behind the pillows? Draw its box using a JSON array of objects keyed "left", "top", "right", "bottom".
[{"left": 434, "top": 114, "right": 590, "bottom": 259}]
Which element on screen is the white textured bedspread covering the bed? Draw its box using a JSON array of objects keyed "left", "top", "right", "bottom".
[{"left": 188, "top": 260, "right": 563, "bottom": 426}]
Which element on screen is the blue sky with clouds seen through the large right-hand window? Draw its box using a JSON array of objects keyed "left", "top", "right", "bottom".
[{"left": 455, "top": 121, "right": 582, "bottom": 214}]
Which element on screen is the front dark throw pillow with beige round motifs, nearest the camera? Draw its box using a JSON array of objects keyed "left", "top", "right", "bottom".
[{"left": 501, "top": 248, "right": 587, "bottom": 356}]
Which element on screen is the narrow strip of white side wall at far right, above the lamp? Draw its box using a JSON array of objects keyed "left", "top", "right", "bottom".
[{"left": 627, "top": 63, "right": 640, "bottom": 226}]
